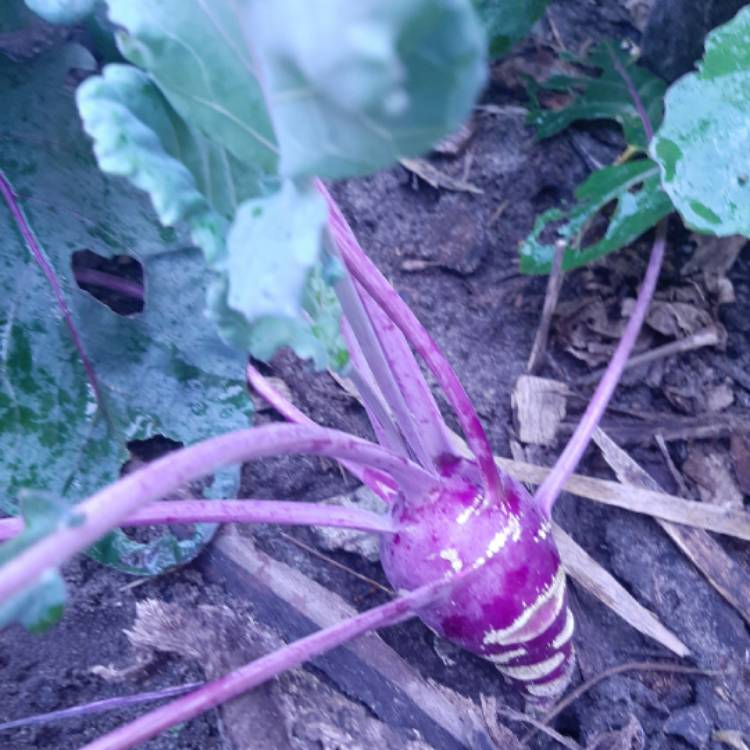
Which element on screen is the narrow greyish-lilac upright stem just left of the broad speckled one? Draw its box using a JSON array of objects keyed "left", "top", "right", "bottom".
[{"left": 336, "top": 262, "right": 433, "bottom": 468}]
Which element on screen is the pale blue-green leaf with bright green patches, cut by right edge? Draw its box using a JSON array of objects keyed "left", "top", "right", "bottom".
[{"left": 651, "top": 8, "right": 750, "bottom": 237}]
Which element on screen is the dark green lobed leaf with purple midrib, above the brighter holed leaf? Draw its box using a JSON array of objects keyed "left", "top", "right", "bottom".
[{"left": 528, "top": 43, "right": 666, "bottom": 149}]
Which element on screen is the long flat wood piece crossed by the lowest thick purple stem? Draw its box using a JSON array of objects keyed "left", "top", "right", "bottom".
[{"left": 209, "top": 527, "right": 492, "bottom": 750}]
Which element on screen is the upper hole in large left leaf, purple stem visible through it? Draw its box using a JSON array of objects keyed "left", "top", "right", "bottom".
[{"left": 71, "top": 250, "right": 144, "bottom": 316}]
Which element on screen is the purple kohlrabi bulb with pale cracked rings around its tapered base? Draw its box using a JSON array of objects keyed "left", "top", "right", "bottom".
[{"left": 381, "top": 458, "right": 574, "bottom": 702}]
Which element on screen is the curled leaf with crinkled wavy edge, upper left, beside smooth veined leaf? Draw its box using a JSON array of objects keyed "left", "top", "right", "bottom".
[{"left": 76, "top": 65, "right": 273, "bottom": 261}]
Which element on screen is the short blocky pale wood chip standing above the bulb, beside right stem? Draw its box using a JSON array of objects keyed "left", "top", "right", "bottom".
[{"left": 511, "top": 375, "right": 570, "bottom": 446}]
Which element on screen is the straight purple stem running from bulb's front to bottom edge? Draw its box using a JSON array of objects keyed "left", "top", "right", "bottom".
[{"left": 81, "top": 552, "right": 488, "bottom": 750}]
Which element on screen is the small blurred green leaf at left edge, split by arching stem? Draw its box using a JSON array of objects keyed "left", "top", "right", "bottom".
[{"left": 0, "top": 492, "right": 71, "bottom": 633}]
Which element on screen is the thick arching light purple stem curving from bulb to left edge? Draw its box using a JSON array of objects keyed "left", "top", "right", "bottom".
[{"left": 0, "top": 424, "right": 436, "bottom": 602}]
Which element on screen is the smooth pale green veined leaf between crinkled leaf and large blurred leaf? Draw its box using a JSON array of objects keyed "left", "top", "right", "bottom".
[{"left": 107, "top": 0, "right": 277, "bottom": 174}]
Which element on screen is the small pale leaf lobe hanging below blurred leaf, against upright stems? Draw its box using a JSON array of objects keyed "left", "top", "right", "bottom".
[{"left": 213, "top": 182, "right": 348, "bottom": 369}]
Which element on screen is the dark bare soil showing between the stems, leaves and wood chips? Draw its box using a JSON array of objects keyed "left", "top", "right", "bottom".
[{"left": 0, "top": 0, "right": 750, "bottom": 750}]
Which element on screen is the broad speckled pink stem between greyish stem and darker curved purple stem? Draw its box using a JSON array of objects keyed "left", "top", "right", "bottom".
[{"left": 359, "top": 289, "right": 455, "bottom": 464}]
